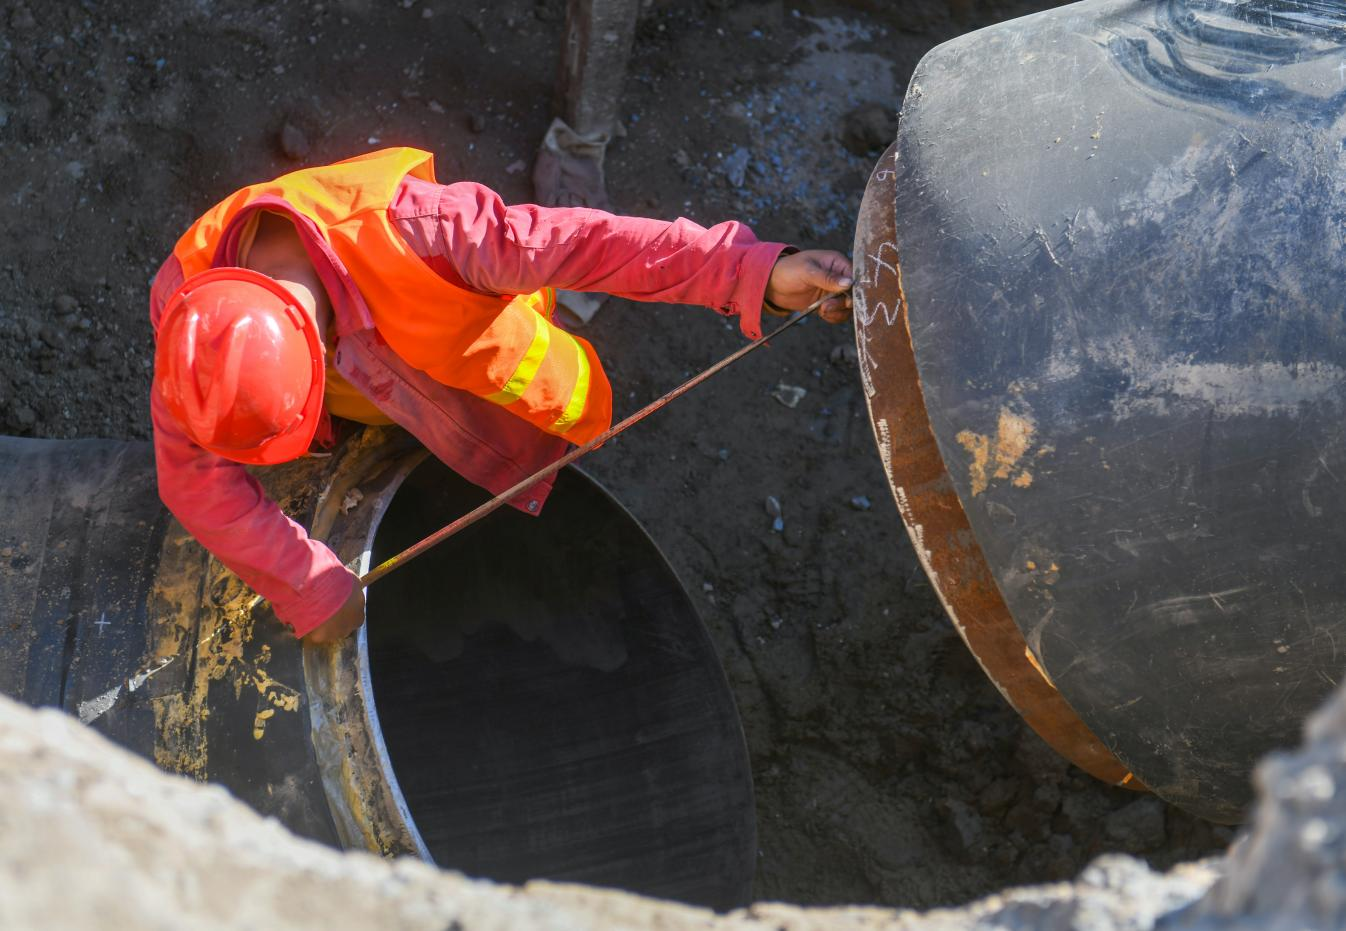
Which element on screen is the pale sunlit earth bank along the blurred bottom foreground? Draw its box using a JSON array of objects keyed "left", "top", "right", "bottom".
[{"left": 0, "top": 675, "right": 1346, "bottom": 931}]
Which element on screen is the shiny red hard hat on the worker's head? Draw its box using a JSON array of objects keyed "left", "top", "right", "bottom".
[{"left": 153, "top": 268, "right": 324, "bottom": 466}]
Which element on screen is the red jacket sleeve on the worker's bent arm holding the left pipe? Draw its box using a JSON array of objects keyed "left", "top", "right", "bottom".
[{"left": 149, "top": 258, "right": 354, "bottom": 636}]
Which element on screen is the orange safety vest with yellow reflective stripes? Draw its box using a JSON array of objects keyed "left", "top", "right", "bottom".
[{"left": 166, "top": 148, "right": 612, "bottom": 444}]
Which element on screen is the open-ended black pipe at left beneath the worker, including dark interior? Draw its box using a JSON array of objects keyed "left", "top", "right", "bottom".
[{"left": 0, "top": 429, "right": 755, "bottom": 908}]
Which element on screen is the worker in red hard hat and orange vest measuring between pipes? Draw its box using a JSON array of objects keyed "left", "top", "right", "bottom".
[{"left": 151, "top": 148, "right": 851, "bottom": 643}]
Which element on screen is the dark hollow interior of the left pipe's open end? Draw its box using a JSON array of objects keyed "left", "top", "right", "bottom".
[{"left": 367, "top": 460, "right": 756, "bottom": 909}]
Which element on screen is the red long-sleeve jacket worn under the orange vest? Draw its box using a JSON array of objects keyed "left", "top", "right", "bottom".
[{"left": 151, "top": 176, "right": 785, "bottom": 635}]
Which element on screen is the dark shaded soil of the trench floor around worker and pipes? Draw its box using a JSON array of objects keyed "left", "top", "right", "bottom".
[{"left": 0, "top": 0, "right": 1232, "bottom": 907}]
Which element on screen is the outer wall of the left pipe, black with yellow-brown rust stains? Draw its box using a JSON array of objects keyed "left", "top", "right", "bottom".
[{"left": 0, "top": 428, "right": 428, "bottom": 860}]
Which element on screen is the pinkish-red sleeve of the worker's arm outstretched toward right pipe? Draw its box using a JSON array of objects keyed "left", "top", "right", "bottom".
[{"left": 409, "top": 182, "right": 786, "bottom": 338}]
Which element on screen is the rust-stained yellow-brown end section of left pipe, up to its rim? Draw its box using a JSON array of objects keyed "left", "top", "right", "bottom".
[{"left": 144, "top": 428, "right": 429, "bottom": 861}]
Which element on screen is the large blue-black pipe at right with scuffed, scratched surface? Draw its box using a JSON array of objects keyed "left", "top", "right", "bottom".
[{"left": 857, "top": 0, "right": 1346, "bottom": 821}]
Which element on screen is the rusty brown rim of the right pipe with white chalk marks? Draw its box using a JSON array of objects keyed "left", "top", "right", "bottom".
[{"left": 853, "top": 143, "right": 1144, "bottom": 790}]
